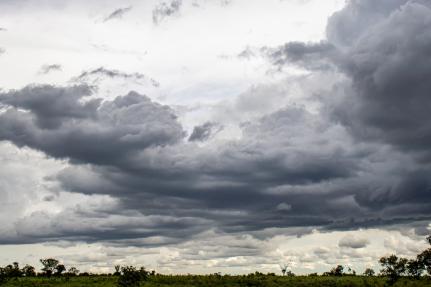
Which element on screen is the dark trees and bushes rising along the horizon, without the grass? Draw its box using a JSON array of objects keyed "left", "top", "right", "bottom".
[{"left": 0, "top": 236, "right": 431, "bottom": 287}]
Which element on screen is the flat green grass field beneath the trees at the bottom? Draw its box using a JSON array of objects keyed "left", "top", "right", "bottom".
[{"left": 2, "top": 275, "right": 431, "bottom": 287}]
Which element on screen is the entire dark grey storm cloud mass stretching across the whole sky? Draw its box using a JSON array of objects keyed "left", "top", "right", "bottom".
[{"left": 0, "top": 0, "right": 431, "bottom": 250}]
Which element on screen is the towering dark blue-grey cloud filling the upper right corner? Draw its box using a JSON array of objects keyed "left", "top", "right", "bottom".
[{"left": 271, "top": 0, "right": 431, "bottom": 160}]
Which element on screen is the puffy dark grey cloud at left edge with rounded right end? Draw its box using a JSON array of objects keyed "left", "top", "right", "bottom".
[{"left": 0, "top": 85, "right": 184, "bottom": 163}]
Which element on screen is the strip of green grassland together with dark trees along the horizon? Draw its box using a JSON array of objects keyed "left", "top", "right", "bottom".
[{"left": 0, "top": 236, "right": 431, "bottom": 287}]
